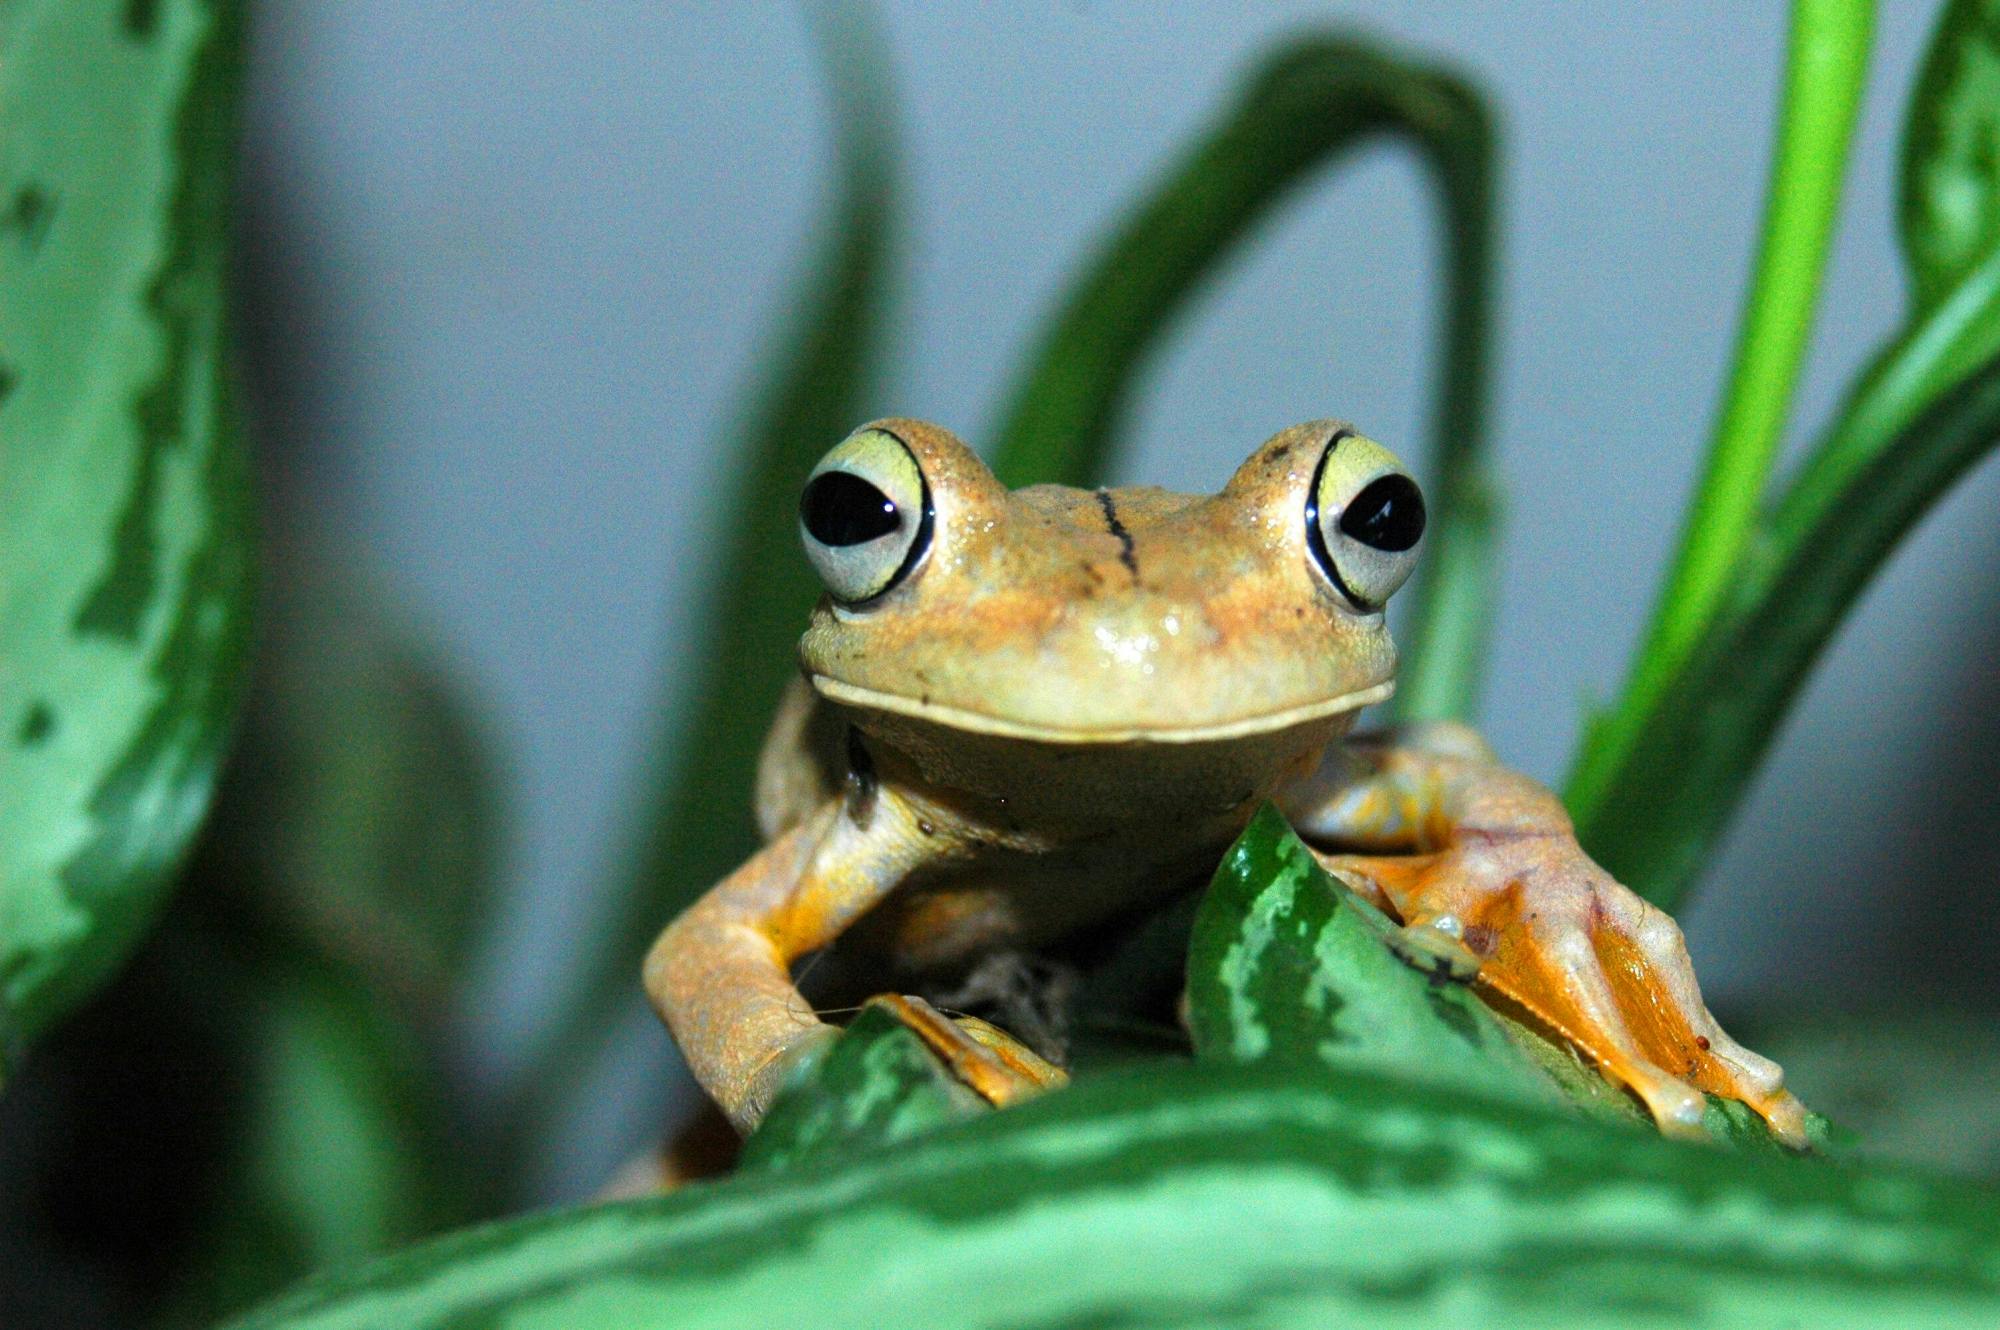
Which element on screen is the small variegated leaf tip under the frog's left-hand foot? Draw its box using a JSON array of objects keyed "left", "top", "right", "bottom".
[{"left": 738, "top": 1006, "right": 988, "bottom": 1172}]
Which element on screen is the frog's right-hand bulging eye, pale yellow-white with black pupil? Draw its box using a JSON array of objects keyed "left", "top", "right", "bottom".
[{"left": 1306, "top": 430, "right": 1424, "bottom": 612}]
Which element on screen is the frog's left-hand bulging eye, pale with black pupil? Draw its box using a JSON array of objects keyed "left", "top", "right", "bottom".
[{"left": 798, "top": 430, "right": 932, "bottom": 604}]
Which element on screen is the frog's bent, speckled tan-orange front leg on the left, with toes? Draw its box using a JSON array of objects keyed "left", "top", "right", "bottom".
[{"left": 646, "top": 788, "right": 1062, "bottom": 1132}]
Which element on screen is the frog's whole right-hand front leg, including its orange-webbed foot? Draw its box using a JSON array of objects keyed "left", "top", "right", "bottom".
[{"left": 1284, "top": 724, "right": 1806, "bottom": 1148}]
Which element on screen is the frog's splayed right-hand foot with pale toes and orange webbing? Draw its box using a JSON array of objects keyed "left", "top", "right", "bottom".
[{"left": 1320, "top": 832, "right": 1806, "bottom": 1148}]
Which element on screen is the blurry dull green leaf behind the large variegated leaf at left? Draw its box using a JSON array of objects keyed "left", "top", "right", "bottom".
[{"left": 212, "top": 572, "right": 498, "bottom": 1028}]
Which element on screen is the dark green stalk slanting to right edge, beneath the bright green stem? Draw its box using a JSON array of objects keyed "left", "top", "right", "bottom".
[{"left": 1578, "top": 360, "right": 2000, "bottom": 910}]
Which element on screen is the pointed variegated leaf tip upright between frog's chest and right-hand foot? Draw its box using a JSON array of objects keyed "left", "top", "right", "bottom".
[{"left": 1188, "top": 804, "right": 1556, "bottom": 1104}]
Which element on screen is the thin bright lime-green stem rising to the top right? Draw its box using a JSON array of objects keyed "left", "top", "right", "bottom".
[{"left": 1568, "top": 0, "right": 1874, "bottom": 814}]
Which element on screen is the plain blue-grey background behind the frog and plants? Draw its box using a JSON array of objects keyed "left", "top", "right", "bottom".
[{"left": 246, "top": 0, "right": 2000, "bottom": 1184}]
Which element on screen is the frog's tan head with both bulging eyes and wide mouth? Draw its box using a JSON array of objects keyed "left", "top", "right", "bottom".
[{"left": 800, "top": 420, "right": 1424, "bottom": 744}]
